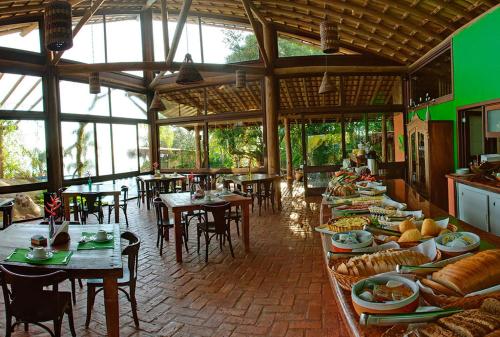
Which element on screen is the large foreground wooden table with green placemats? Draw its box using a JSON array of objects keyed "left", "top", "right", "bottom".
[{"left": 0, "top": 223, "right": 123, "bottom": 337}]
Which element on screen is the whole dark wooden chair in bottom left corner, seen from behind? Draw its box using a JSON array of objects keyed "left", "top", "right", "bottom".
[{"left": 0, "top": 266, "right": 76, "bottom": 337}]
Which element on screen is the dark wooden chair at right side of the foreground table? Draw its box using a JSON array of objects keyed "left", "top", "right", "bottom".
[{"left": 85, "top": 232, "right": 141, "bottom": 328}]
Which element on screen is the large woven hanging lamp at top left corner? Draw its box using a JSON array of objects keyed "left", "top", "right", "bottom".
[{"left": 44, "top": 0, "right": 73, "bottom": 51}]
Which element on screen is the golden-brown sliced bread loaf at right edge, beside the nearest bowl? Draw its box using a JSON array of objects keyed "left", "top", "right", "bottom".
[{"left": 432, "top": 249, "right": 500, "bottom": 295}]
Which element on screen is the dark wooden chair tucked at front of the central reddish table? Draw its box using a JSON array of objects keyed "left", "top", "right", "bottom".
[{"left": 197, "top": 202, "right": 234, "bottom": 262}]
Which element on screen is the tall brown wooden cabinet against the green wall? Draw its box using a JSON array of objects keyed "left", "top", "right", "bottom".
[{"left": 407, "top": 114, "right": 453, "bottom": 209}]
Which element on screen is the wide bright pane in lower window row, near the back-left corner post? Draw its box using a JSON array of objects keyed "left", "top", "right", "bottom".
[{"left": 113, "top": 124, "right": 138, "bottom": 173}]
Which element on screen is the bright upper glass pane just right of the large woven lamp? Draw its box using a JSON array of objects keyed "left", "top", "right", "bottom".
[{"left": 63, "top": 20, "right": 106, "bottom": 63}]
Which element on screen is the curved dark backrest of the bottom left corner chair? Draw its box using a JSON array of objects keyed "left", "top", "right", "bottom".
[{"left": 0, "top": 265, "right": 68, "bottom": 319}]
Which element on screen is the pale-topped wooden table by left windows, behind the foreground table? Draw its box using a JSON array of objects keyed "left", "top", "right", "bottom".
[{"left": 62, "top": 183, "right": 122, "bottom": 223}]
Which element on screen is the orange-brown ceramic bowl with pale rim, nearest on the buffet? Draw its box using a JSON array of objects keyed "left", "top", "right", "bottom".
[{"left": 351, "top": 275, "right": 419, "bottom": 315}]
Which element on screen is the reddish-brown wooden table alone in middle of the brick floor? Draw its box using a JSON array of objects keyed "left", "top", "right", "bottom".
[{"left": 160, "top": 192, "right": 252, "bottom": 263}]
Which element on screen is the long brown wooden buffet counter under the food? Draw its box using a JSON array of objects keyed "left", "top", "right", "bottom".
[{"left": 320, "top": 179, "right": 500, "bottom": 337}]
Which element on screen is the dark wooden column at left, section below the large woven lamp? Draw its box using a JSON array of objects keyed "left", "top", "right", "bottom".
[{"left": 44, "top": 66, "right": 64, "bottom": 192}]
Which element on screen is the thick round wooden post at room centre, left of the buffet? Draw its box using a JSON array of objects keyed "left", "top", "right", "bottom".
[{"left": 262, "top": 25, "right": 281, "bottom": 209}]
